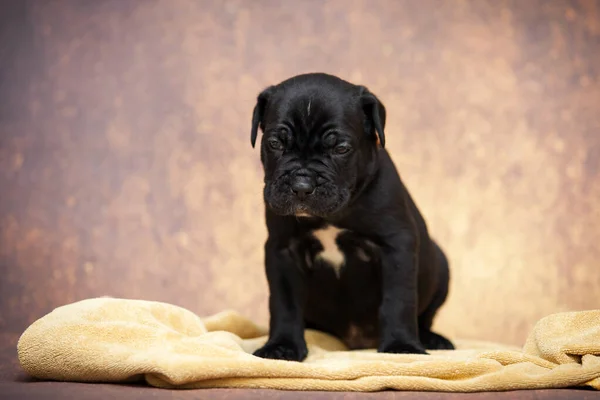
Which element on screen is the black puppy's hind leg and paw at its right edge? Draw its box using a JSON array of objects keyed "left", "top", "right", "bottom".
[{"left": 419, "top": 242, "right": 454, "bottom": 350}]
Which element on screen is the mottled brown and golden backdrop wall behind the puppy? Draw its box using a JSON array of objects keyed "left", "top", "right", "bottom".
[{"left": 0, "top": 0, "right": 600, "bottom": 344}]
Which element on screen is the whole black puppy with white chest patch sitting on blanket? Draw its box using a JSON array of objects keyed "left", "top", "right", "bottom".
[{"left": 251, "top": 73, "right": 453, "bottom": 361}]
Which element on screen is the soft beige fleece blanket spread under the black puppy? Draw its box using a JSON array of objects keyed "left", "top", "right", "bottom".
[{"left": 18, "top": 298, "right": 600, "bottom": 392}]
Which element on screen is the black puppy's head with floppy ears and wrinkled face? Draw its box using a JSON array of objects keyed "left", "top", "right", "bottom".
[{"left": 251, "top": 74, "right": 386, "bottom": 218}]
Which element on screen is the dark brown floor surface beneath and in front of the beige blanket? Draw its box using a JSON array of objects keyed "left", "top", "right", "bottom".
[{"left": 0, "top": 333, "right": 600, "bottom": 400}]
